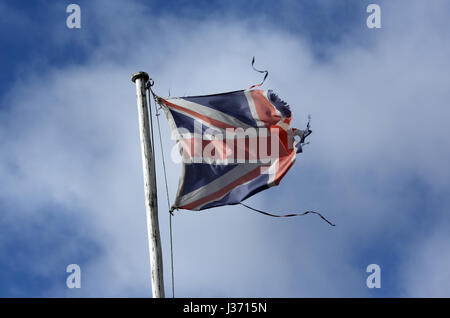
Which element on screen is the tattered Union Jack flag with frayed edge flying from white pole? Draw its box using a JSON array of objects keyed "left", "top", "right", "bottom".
[{"left": 156, "top": 89, "right": 311, "bottom": 210}]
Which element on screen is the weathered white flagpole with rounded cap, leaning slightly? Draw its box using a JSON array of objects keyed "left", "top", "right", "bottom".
[{"left": 131, "top": 72, "right": 165, "bottom": 298}]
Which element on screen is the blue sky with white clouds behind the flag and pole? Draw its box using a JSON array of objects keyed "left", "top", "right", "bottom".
[{"left": 0, "top": 0, "right": 450, "bottom": 297}]
